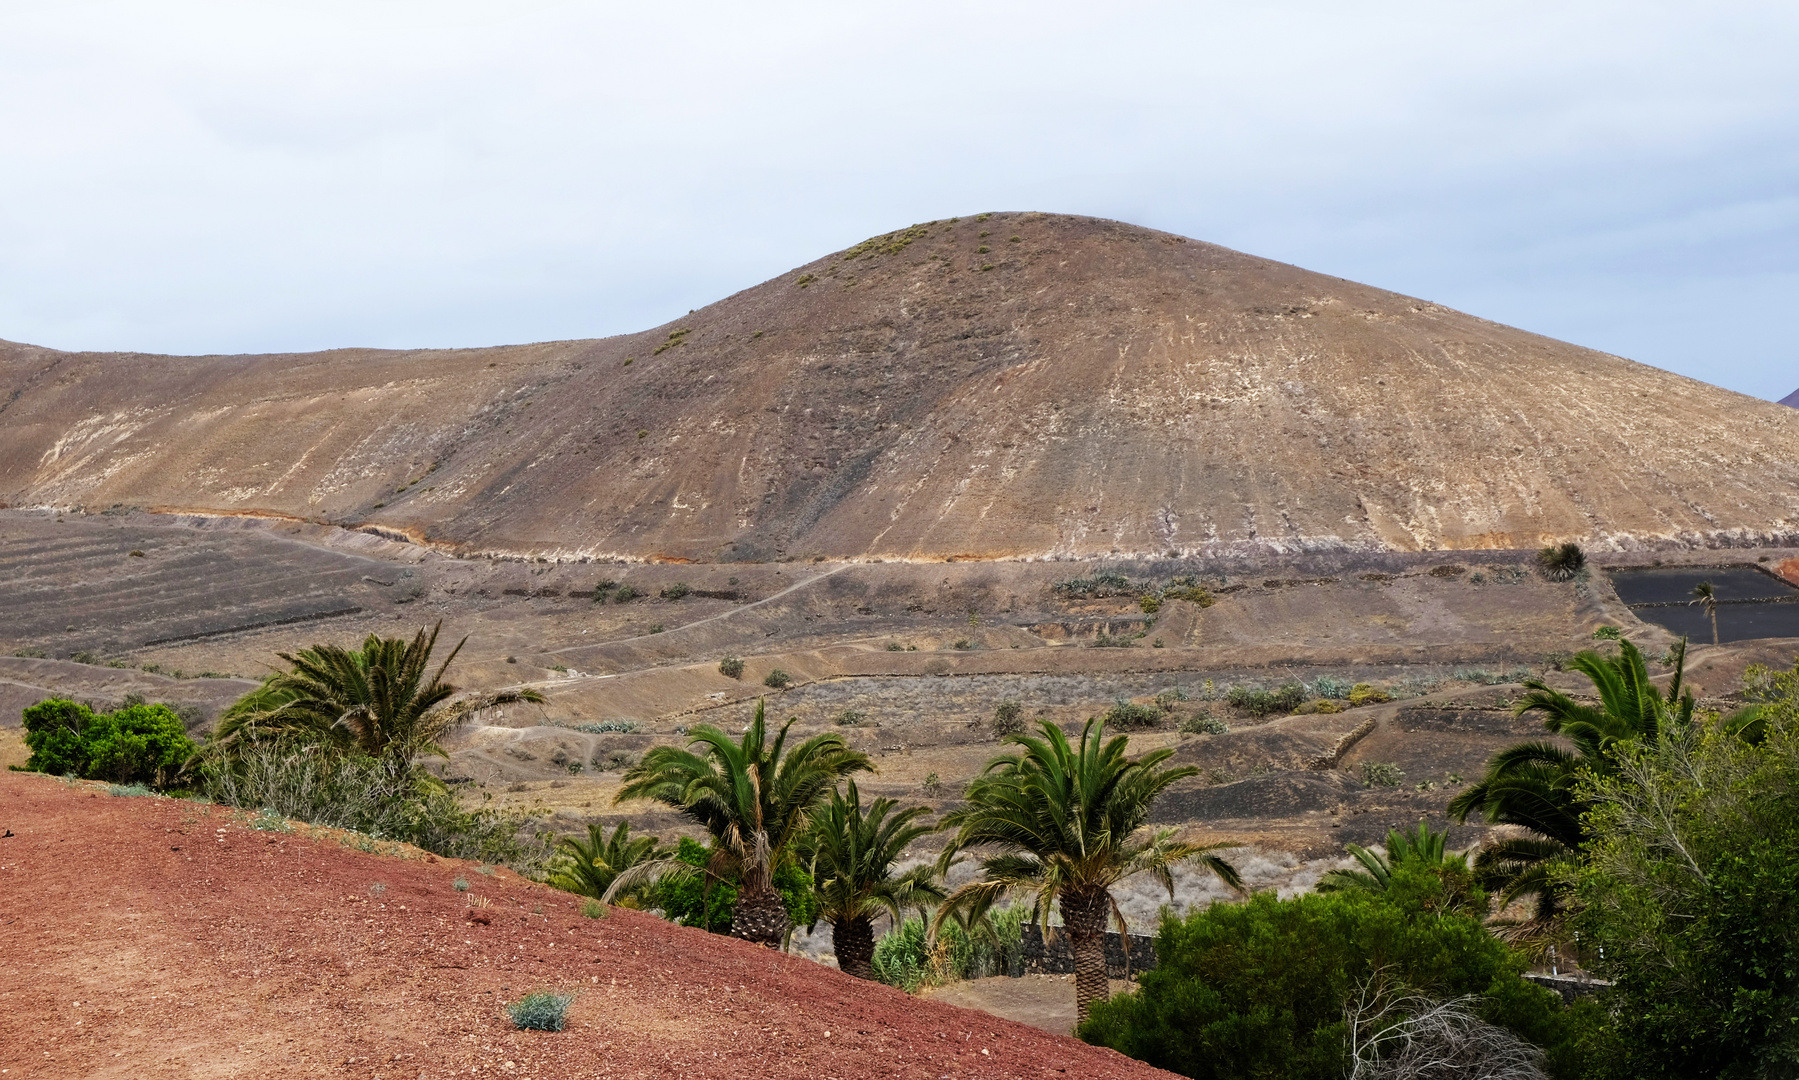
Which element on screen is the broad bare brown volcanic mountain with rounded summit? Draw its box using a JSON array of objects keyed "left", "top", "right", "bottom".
[{"left": 0, "top": 212, "right": 1799, "bottom": 562}]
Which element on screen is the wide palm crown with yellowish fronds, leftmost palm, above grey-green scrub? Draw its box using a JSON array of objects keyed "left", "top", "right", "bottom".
[{"left": 212, "top": 621, "right": 543, "bottom": 769}]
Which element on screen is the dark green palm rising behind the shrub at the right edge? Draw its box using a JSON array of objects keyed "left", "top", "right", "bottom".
[{"left": 1448, "top": 639, "right": 1695, "bottom": 927}]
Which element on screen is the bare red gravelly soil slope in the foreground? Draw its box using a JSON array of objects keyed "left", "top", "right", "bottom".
[{"left": 0, "top": 774, "right": 1168, "bottom": 1080}]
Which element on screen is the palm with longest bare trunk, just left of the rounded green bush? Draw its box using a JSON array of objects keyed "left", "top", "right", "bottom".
[{"left": 934, "top": 716, "right": 1241, "bottom": 1021}]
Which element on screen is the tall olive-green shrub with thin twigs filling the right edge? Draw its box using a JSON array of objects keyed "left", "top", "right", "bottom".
[{"left": 1571, "top": 709, "right": 1799, "bottom": 1080}]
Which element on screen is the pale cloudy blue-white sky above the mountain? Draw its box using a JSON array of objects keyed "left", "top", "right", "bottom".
[{"left": 0, "top": 0, "right": 1799, "bottom": 398}]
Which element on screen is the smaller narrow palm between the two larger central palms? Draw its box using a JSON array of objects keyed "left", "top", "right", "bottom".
[{"left": 801, "top": 779, "right": 946, "bottom": 979}]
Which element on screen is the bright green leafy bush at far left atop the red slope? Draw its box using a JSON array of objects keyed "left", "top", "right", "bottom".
[{"left": 23, "top": 698, "right": 196, "bottom": 787}]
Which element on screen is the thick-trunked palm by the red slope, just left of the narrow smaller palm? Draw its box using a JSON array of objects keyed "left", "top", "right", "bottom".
[{"left": 608, "top": 700, "right": 874, "bottom": 947}]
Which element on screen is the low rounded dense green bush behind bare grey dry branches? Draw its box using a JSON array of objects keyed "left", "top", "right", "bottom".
[{"left": 1079, "top": 868, "right": 1576, "bottom": 1080}]
